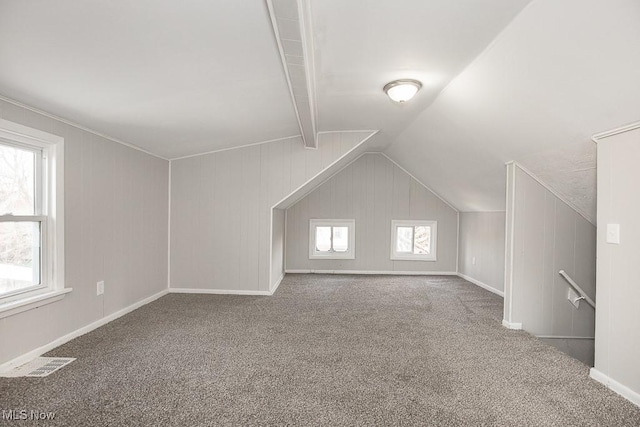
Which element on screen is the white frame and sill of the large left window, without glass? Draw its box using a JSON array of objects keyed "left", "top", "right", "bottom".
[{"left": 0, "top": 119, "right": 65, "bottom": 310}]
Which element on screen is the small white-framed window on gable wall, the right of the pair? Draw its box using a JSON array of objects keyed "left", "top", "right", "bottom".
[{"left": 391, "top": 220, "right": 438, "bottom": 261}]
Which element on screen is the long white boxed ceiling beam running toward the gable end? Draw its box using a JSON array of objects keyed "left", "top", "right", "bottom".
[{"left": 266, "top": 0, "right": 318, "bottom": 149}]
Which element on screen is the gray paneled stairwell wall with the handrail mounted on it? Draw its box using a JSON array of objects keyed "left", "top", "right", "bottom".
[{"left": 505, "top": 164, "right": 596, "bottom": 337}]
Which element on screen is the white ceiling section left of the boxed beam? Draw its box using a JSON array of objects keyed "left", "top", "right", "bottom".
[{"left": 0, "top": 0, "right": 300, "bottom": 158}]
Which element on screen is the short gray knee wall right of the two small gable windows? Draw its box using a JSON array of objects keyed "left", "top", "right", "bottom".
[{"left": 458, "top": 212, "right": 505, "bottom": 292}]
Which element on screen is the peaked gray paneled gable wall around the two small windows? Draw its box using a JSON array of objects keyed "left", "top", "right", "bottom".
[{"left": 286, "top": 153, "right": 458, "bottom": 273}]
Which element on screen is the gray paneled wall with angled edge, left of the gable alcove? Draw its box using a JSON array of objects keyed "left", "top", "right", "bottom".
[{"left": 170, "top": 132, "right": 371, "bottom": 292}]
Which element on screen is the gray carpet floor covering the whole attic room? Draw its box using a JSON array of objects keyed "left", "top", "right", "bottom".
[{"left": 0, "top": 275, "right": 640, "bottom": 426}]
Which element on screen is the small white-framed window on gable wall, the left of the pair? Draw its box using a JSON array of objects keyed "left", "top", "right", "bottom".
[{"left": 309, "top": 219, "right": 356, "bottom": 259}]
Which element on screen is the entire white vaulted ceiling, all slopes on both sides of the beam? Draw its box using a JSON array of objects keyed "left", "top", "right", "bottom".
[{"left": 0, "top": 0, "right": 640, "bottom": 218}]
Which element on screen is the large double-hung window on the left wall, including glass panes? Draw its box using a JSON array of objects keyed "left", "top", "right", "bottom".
[{"left": 0, "top": 120, "right": 64, "bottom": 309}]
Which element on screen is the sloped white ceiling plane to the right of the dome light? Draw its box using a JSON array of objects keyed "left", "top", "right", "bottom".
[{"left": 388, "top": 0, "right": 640, "bottom": 220}]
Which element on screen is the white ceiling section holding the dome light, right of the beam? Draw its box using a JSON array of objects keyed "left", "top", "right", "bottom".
[{"left": 311, "top": 0, "right": 530, "bottom": 139}]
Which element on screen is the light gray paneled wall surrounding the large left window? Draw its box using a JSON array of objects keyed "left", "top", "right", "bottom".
[{"left": 0, "top": 101, "right": 169, "bottom": 363}]
